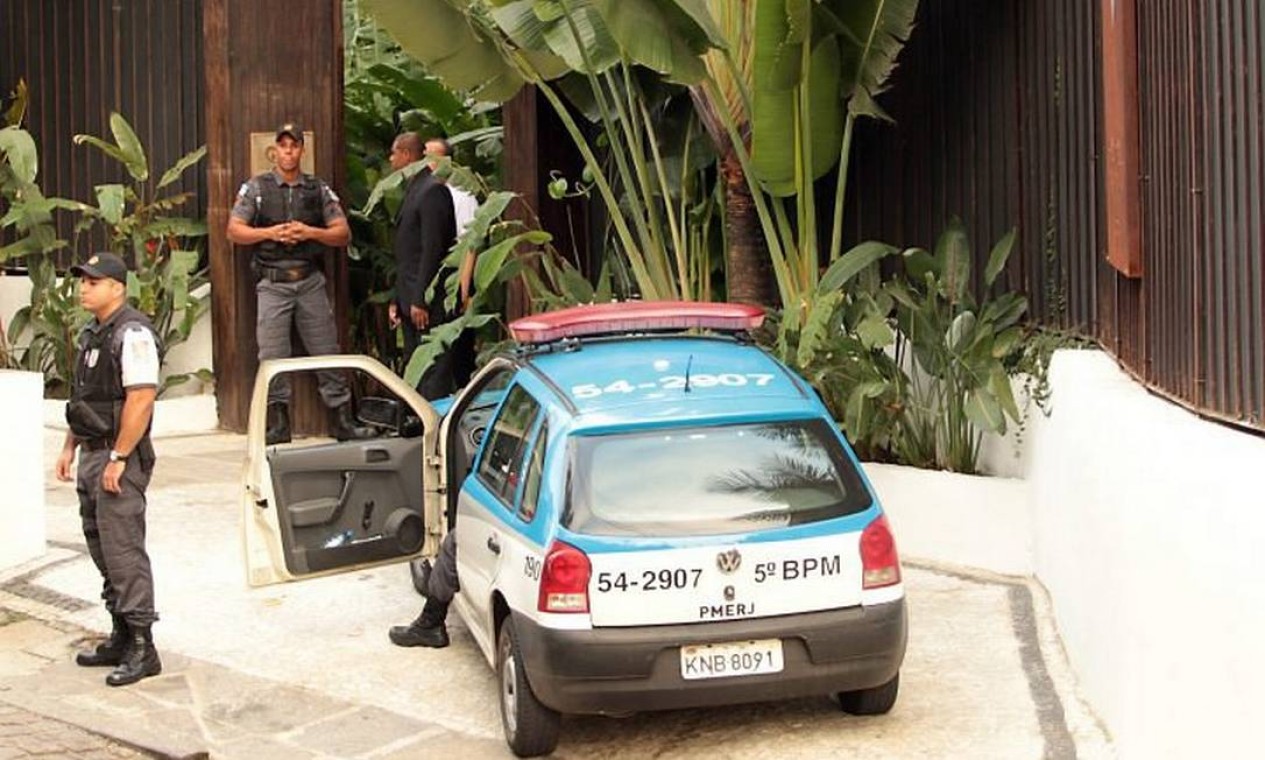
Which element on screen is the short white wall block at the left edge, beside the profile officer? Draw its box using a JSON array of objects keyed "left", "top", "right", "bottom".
[{"left": 0, "top": 369, "right": 46, "bottom": 570}]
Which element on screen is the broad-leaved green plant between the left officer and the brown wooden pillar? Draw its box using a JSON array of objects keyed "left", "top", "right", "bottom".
[{"left": 73, "top": 113, "right": 213, "bottom": 392}]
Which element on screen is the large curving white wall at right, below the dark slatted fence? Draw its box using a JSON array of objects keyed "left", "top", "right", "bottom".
[{"left": 1028, "top": 352, "right": 1265, "bottom": 757}]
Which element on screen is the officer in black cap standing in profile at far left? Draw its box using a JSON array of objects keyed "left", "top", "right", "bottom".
[{"left": 57, "top": 253, "right": 162, "bottom": 687}]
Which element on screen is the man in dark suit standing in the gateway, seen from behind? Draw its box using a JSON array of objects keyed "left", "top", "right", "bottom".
[{"left": 390, "top": 132, "right": 457, "bottom": 400}]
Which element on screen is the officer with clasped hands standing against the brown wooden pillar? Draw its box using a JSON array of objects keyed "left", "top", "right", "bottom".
[{"left": 226, "top": 124, "right": 372, "bottom": 445}]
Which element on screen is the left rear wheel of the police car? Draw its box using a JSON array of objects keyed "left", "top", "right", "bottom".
[{"left": 496, "top": 618, "right": 562, "bottom": 757}]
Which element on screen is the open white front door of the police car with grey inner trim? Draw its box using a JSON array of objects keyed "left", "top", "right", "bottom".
[{"left": 242, "top": 354, "right": 445, "bottom": 585}]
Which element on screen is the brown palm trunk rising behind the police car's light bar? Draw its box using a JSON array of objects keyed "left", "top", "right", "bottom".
[{"left": 720, "top": 150, "right": 777, "bottom": 307}]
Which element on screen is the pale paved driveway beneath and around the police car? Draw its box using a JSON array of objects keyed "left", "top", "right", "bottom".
[{"left": 0, "top": 434, "right": 1111, "bottom": 759}]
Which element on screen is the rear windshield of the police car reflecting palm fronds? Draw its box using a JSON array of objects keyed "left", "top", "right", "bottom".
[{"left": 563, "top": 420, "right": 870, "bottom": 536}]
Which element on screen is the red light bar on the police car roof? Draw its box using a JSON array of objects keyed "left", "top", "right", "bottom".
[{"left": 510, "top": 301, "right": 764, "bottom": 344}]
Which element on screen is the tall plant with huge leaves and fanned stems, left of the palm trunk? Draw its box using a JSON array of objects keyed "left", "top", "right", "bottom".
[{"left": 367, "top": 0, "right": 720, "bottom": 298}]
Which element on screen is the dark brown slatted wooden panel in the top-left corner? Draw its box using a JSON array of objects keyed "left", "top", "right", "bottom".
[{"left": 0, "top": 0, "right": 206, "bottom": 266}]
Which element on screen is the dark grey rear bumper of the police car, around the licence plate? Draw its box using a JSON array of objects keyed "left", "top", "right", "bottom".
[{"left": 514, "top": 599, "right": 907, "bottom": 713}]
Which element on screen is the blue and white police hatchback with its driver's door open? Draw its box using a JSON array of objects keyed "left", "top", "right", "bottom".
[{"left": 244, "top": 302, "right": 906, "bottom": 756}]
